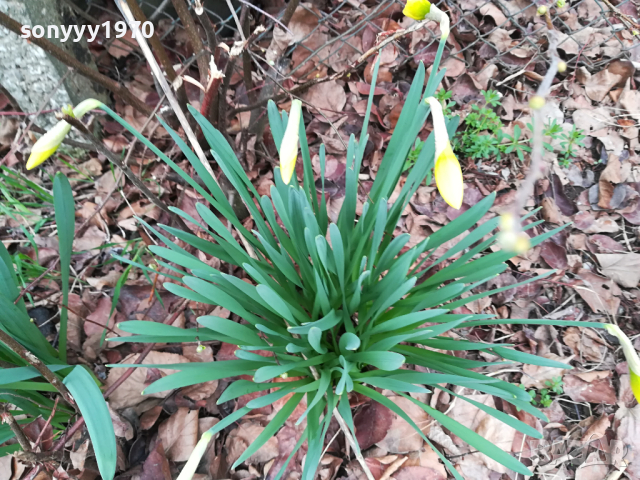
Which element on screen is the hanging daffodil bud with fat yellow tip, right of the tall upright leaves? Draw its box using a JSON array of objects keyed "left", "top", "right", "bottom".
[{"left": 425, "top": 97, "right": 464, "bottom": 210}]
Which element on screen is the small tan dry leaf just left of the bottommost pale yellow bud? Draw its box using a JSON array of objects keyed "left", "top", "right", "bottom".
[{"left": 158, "top": 407, "right": 198, "bottom": 462}]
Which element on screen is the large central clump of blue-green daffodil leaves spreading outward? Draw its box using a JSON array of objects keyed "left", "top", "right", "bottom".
[{"left": 104, "top": 64, "right": 594, "bottom": 480}]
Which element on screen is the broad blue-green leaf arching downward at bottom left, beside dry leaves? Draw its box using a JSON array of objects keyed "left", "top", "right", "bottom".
[{"left": 64, "top": 366, "right": 117, "bottom": 480}]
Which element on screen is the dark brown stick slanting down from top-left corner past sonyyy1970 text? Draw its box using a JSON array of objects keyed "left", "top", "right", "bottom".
[{"left": 0, "top": 12, "right": 151, "bottom": 115}]
